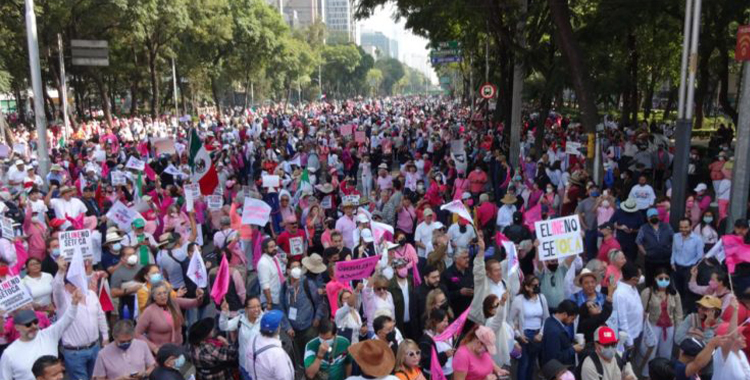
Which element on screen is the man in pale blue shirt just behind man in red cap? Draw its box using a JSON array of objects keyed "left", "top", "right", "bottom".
[{"left": 613, "top": 262, "right": 643, "bottom": 348}]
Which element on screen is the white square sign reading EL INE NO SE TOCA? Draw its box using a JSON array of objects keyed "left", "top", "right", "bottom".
[{"left": 534, "top": 215, "right": 583, "bottom": 261}]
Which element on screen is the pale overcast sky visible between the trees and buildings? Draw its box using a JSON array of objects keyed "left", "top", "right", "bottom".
[{"left": 359, "top": 3, "right": 437, "bottom": 83}]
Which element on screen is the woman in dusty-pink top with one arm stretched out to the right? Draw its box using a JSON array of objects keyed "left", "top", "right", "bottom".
[{"left": 135, "top": 282, "right": 203, "bottom": 354}]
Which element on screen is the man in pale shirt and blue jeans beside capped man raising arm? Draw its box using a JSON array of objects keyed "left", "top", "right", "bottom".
[{"left": 52, "top": 259, "right": 109, "bottom": 379}]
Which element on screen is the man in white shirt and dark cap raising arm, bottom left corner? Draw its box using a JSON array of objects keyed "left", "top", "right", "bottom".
[{"left": 0, "top": 291, "right": 83, "bottom": 380}]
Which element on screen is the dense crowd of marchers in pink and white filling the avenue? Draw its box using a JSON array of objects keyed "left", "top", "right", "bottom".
[{"left": 0, "top": 97, "right": 750, "bottom": 380}]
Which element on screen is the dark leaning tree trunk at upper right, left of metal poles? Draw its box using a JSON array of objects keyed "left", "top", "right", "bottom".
[{"left": 547, "top": 0, "right": 599, "bottom": 134}]
